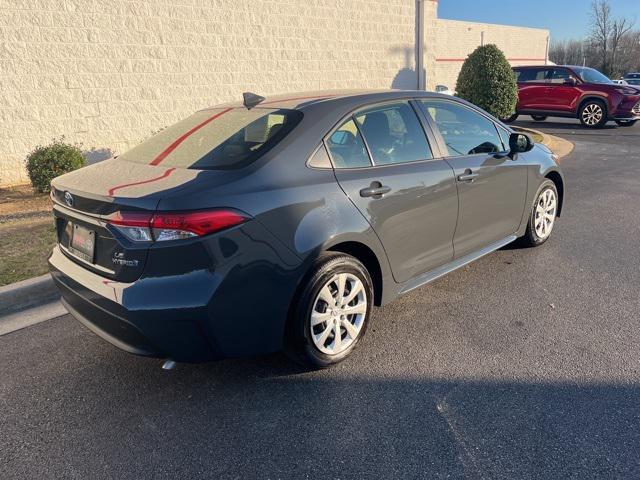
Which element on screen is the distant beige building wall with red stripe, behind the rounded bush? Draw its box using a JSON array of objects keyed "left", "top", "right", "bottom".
[{"left": 429, "top": 19, "right": 549, "bottom": 90}]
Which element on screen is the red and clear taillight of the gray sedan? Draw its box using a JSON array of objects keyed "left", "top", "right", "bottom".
[{"left": 108, "top": 209, "right": 250, "bottom": 242}]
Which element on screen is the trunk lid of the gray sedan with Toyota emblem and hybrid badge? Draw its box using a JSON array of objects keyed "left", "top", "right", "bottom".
[{"left": 51, "top": 159, "right": 199, "bottom": 282}]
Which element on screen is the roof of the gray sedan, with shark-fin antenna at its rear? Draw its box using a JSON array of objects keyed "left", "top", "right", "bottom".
[{"left": 203, "top": 89, "right": 451, "bottom": 110}]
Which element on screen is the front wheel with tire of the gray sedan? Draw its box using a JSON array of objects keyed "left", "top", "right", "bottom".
[{"left": 519, "top": 179, "right": 560, "bottom": 247}]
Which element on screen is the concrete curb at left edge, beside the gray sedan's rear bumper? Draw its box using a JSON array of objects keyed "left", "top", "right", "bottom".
[{"left": 0, "top": 273, "right": 60, "bottom": 317}]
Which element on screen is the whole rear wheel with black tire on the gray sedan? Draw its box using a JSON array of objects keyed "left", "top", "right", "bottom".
[{"left": 285, "top": 252, "right": 374, "bottom": 368}]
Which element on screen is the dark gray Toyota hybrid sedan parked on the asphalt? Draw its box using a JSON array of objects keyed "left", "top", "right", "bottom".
[{"left": 49, "top": 91, "right": 564, "bottom": 367}]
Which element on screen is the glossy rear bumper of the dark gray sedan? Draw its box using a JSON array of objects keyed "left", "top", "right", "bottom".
[{"left": 49, "top": 222, "right": 304, "bottom": 362}]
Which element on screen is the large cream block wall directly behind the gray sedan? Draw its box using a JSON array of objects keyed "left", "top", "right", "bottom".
[{"left": 0, "top": 0, "right": 437, "bottom": 185}]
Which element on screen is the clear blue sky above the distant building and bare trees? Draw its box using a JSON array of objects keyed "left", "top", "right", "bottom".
[{"left": 438, "top": 0, "right": 640, "bottom": 40}]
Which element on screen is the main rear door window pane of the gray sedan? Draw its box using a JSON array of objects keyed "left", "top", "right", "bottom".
[{"left": 355, "top": 101, "right": 433, "bottom": 165}]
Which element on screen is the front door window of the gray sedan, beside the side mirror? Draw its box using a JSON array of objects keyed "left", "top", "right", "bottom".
[{"left": 421, "top": 100, "right": 504, "bottom": 157}]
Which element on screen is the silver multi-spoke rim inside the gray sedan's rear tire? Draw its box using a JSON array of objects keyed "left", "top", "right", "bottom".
[{"left": 309, "top": 273, "right": 367, "bottom": 355}]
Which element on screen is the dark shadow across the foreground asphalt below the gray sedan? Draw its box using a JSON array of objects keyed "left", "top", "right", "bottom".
[{"left": 5, "top": 341, "right": 640, "bottom": 479}]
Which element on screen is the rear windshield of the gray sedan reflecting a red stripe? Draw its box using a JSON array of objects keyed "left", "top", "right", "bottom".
[{"left": 118, "top": 108, "right": 302, "bottom": 170}]
